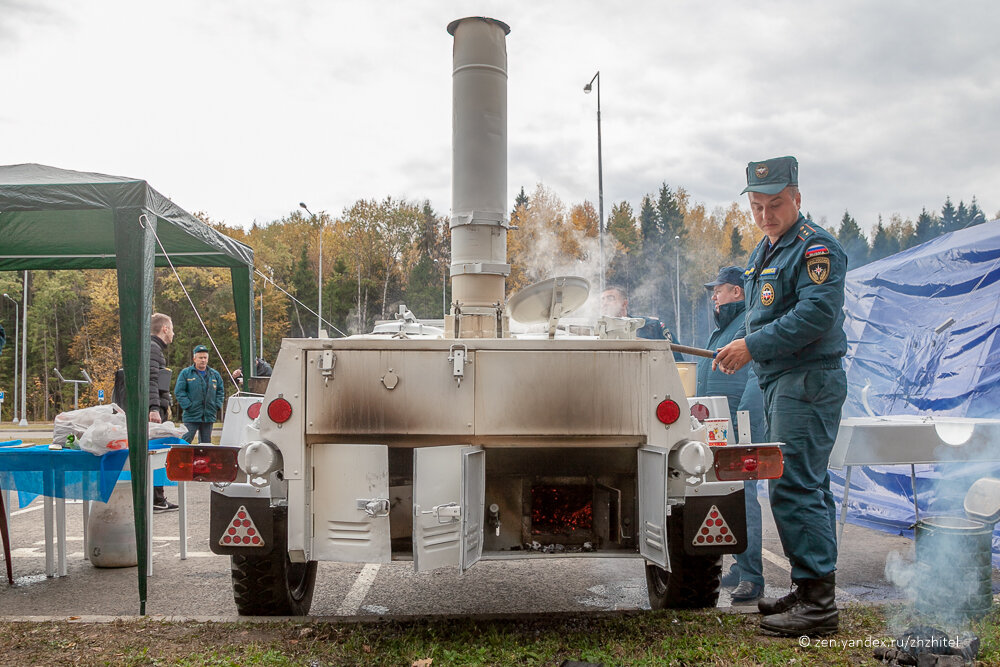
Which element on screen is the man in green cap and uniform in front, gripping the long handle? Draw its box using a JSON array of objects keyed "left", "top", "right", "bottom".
[{"left": 712, "top": 157, "right": 847, "bottom": 636}]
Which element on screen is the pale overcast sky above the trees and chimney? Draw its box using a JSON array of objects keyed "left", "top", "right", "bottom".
[{"left": 0, "top": 0, "right": 1000, "bottom": 235}]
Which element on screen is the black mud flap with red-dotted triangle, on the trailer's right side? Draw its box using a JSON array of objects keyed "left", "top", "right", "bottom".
[{"left": 684, "top": 489, "right": 747, "bottom": 556}]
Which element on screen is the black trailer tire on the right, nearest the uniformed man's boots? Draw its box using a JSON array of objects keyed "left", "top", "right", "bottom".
[{"left": 646, "top": 508, "right": 722, "bottom": 609}]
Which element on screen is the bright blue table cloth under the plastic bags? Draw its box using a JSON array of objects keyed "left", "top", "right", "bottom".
[{"left": 0, "top": 438, "right": 187, "bottom": 507}]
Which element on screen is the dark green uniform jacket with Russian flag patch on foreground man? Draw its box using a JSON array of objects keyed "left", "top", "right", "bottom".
[{"left": 736, "top": 214, "right": 847, "bottom": 385}]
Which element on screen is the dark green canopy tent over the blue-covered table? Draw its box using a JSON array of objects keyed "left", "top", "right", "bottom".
[{"left": 0, "top": 164, "right": 254, "bottom": 614}]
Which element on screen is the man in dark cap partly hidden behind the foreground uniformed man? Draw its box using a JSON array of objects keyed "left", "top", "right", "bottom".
[{"left": 695, "top": 266, "right": 767, "bottom": 605}]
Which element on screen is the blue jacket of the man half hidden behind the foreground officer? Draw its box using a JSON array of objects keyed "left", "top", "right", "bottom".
[{"left": 695, "top": 301, "right": 767, "bottom": 442}]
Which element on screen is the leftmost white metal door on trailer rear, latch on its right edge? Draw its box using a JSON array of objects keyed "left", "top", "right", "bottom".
[{"left": 311, "top": 445, "right": 392, "bottom": 563}]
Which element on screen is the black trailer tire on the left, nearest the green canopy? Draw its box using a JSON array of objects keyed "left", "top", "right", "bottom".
[{"left": 231, "top": 508, "right": 317, "bottom": 616}]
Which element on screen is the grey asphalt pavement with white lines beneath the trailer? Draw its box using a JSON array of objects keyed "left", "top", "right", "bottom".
[{"left": 0, "top": 484, "right": 984, "bottom": 619}]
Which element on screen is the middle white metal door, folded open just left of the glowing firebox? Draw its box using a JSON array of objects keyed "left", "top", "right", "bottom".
[{"left": 413, "top": 445, "right": 486, "bottom": 572}]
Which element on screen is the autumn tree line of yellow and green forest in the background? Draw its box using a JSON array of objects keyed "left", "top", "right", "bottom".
[{"left": 0, "top": 183, "right": 986, "bottom": 421}]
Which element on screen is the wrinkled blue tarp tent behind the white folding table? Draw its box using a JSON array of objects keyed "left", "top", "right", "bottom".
[{"left": 830, "top": 220, "right": 1000, "bottom": 567}]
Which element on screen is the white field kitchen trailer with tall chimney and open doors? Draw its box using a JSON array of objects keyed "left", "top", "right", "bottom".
[{"left": 168, "top": 17, "right": 782, "bottom": 615}]
